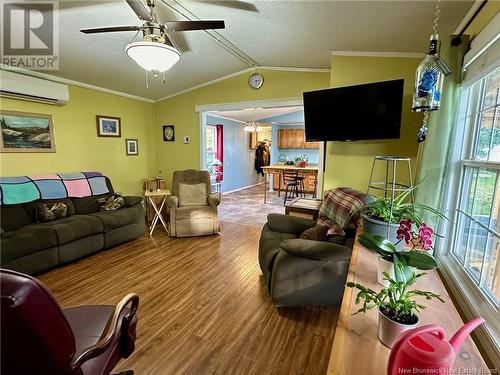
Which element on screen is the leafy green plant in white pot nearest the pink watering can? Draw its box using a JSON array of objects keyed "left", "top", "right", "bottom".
[{"left": 346, "top": 272, "right": 444, "bottom": 348}]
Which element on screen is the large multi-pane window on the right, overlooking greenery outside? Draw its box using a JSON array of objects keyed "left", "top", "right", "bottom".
[{"left": 451, "top": 68, "right": 500, "bottom": 311}]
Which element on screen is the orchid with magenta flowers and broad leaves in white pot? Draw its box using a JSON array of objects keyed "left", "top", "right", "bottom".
[{"left": 358, "top": 220, "right": 437, "bottom": 287}]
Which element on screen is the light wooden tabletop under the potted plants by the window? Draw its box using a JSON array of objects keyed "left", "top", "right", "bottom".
[{"left": 327, "top": 236, "right": 489, "bottom": 375}]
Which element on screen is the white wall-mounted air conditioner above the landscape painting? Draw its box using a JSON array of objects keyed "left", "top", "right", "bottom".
[{"left": 0, "top": 70, "right": 69, "bottom": 105}]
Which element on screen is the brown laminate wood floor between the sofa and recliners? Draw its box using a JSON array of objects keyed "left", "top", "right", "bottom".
[{"left": 39, "top": 223, "right": 338, "bottom": 375}]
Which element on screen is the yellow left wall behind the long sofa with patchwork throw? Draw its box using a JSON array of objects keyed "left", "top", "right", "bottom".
[{"left": 0, "top": 86, "right": 155, "bottom": 195}]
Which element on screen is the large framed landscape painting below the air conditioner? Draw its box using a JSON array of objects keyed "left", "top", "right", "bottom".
[{"left": 0, "top": 111, "right": 56, "bottom": 152}]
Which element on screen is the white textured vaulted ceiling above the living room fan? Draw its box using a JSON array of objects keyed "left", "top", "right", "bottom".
[{"left": 41, "top": 0, "right": 472, "bottom": 99}]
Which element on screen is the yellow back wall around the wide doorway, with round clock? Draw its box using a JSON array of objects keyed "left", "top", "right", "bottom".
[{"left": 155, "top": 71, "right": 330, "bottom": 186}]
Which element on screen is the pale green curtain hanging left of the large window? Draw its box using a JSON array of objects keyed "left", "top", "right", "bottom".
[{"left": 415, "top": 35, "right": 469, "bottom": 232}]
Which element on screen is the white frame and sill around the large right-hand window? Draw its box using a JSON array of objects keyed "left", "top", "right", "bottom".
[{"left": 436, "top": 68, "right": 500, "bottom": 364}]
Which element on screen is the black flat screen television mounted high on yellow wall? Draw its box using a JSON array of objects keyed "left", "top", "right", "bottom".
[{"left": 304, "top": 79, "right": 404, "bottom": 141}]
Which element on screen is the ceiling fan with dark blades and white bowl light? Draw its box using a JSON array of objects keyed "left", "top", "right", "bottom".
[{"left": 80, "top": 0, "right": 225, "bottom": 77}]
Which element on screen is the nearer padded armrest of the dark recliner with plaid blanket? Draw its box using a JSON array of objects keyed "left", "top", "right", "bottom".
[{"left": 281, "top": 238, "right": 351, "bottom": 261}]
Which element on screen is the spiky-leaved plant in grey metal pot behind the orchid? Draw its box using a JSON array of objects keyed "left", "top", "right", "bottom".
[{"left": 361, "top": 183, "right": 448, "bottom": 248}]
